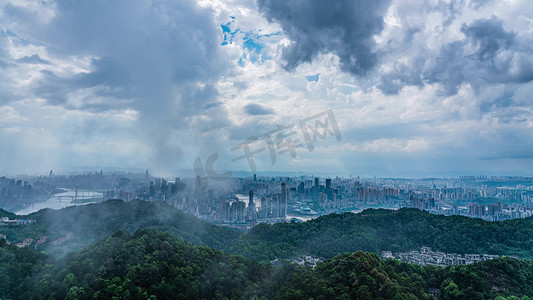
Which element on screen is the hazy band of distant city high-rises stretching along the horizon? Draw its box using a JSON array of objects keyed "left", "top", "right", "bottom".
[{"left": 0, "top": 171, "right": 533, "bottom": 229}]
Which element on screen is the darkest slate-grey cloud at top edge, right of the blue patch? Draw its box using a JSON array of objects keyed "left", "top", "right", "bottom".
[{"left": 258, "top": 0, "right": 390, "bottom": 75}]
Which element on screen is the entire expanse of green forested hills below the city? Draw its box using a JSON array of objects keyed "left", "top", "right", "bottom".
[{"left": 0, "top": 200, "right": 533, "bottom": 300}]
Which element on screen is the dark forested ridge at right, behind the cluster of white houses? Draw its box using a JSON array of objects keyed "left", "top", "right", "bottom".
[{"left": 230, "top": 209, "right": 533, "bottom": 260}]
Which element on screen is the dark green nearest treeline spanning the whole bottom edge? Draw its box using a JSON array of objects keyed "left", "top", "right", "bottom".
[{"left": 0, "top": 229, "right": 533, "bottom": 299}]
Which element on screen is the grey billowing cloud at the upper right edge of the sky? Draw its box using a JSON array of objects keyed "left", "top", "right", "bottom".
[{"left": 378, "top": 17, "right": 533, "bottom": 96}]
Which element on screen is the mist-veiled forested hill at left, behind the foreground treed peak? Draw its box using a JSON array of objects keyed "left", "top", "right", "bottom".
[{"left": 0, "top": 200, "right": 241, "bottom": 253}]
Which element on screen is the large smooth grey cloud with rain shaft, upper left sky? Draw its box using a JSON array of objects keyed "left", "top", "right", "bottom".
[{"left": 0, "top": 0, "right": 231, "bottom": 170}]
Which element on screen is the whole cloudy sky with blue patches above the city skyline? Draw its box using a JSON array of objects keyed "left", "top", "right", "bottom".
[{"left": 0, "top": 0, "right": 533, "bottom": 177}]
